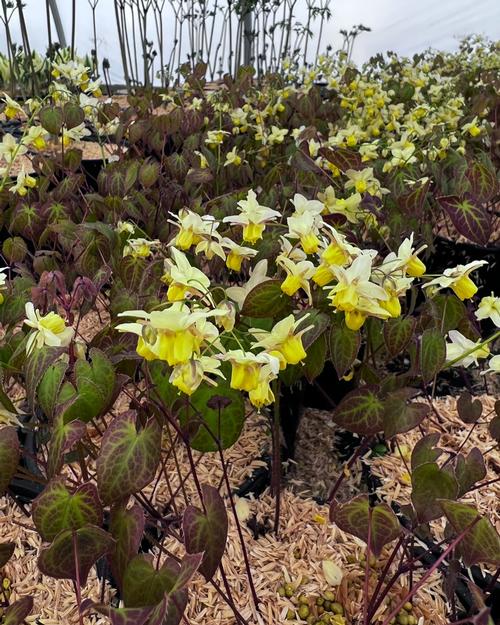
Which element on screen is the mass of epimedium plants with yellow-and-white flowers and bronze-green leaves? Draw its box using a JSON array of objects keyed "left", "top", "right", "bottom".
[{"left": 0, "top": 41, "right": 500, "bottom": 625}]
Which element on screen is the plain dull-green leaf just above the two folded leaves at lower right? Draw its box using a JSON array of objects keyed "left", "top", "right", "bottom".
[{"left": 411, "top": 462, "right": 458, "bottom": 523}]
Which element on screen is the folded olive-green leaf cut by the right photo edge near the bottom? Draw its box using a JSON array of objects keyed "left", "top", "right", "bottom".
[{"left": 440, "top": 501, "right": 500, "bottom": 567}]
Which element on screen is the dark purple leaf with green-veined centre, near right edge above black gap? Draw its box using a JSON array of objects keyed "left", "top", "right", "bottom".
[{"left": 437, "top": 194, "right": 492, "bottom": 245}]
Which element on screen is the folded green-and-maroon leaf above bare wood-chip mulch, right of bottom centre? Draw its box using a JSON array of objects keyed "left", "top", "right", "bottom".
[{"left": 330, "top": 495, "right": 401, "bottom": 556}]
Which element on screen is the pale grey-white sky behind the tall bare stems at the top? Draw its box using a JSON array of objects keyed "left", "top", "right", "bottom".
[{"left": 0, "top": 0, "right": 500, "bottom": 83}]
